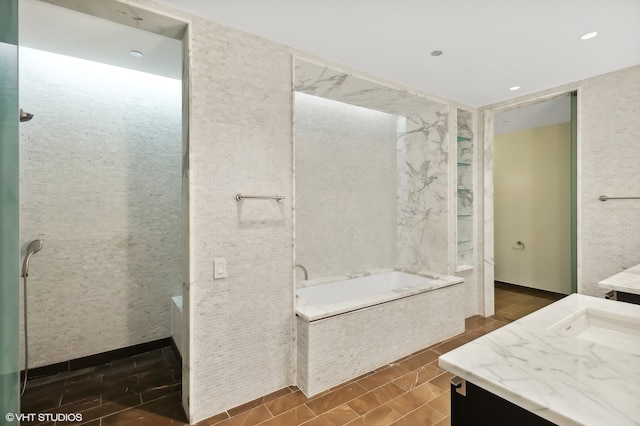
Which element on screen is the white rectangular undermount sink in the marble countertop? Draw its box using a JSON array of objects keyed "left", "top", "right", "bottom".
[{"left": 549, "top": 307, "right": 640, "bottom": 355}]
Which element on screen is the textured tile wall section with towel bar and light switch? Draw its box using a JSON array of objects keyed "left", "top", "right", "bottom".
[{"left": 189, "top": 18, "right": 293, "bottom": 422}]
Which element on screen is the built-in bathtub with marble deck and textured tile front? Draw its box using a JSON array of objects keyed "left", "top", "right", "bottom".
[{"left": 296, "top": 270, "right": 465, "bottom": 397}]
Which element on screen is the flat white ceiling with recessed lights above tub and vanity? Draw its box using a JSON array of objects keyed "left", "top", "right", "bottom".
[{"left": 154, "top": 0, "right": 640, "bottom": 107}]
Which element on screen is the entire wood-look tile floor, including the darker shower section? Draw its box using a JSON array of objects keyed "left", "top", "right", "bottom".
[{"left": 20, "top": 283, "right": 563, "bottom": 426}]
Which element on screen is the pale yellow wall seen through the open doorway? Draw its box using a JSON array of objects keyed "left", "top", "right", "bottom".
[{"left": 494, "top": 123, "right": 571, "bottom": 294}]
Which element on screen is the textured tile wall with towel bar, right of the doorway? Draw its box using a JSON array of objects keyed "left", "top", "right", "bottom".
[{"left": 578, "top": 66, "right": 640, "bottom": 296}]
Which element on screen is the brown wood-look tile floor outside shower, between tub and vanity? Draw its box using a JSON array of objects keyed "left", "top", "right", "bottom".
[{"left": 198, "top": 283, "right": 564, "bottom": 426}]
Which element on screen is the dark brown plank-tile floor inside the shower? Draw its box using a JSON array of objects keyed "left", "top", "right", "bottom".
[{"left": 20, "top": 347, "right": 187, "bottom": 426}]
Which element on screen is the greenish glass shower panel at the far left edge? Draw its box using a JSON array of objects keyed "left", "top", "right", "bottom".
[{"left": 0, "top": 0, "right": 20, "bottom": 416}]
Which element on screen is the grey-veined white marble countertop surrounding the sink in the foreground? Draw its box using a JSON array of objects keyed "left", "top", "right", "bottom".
[{"left": 439, "top": 294, "right": 640, "bottom": 426}]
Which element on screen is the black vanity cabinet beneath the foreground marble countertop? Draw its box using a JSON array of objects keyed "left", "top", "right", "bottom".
[{"left": 451, "top": 377, "right": 555, "bottom": 426}]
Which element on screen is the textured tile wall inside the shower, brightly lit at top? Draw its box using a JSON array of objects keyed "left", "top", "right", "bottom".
[{"left": 20, "top": 48, "right": 182, "bottom": 367}]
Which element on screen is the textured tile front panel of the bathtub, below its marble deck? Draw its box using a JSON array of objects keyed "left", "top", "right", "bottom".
[{"left": 297, "top": 284, "right": 465, "bottom": 396}]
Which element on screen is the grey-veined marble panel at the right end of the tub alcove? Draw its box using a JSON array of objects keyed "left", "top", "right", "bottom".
[{"left": 397, "top": 105, "right": 449, "bottom": 272}]
